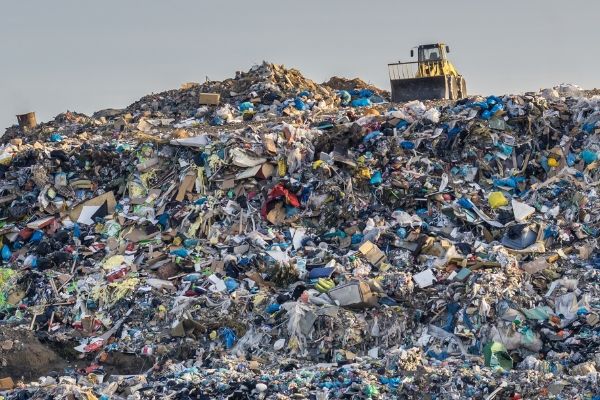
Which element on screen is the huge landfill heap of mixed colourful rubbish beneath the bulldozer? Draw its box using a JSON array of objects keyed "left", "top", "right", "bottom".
[{"left": 0, "top": 63, "right": 600, "bottom": 400}]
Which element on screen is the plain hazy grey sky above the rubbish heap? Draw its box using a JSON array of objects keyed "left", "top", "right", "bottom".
[{"left": 0, "top": 0, "right": 600, "bottom": 133}]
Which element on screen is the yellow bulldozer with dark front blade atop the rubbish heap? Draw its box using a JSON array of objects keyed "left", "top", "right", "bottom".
[{"left": 388, "top": 43, "right": 467, "bottom": 103}]
